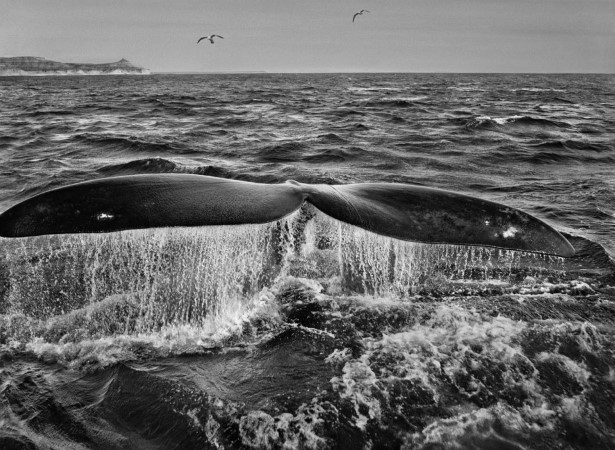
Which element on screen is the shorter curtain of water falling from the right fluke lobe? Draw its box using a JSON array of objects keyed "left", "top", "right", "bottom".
[{"left": 306, "top": 216, "right": 563, "bottom": 297}]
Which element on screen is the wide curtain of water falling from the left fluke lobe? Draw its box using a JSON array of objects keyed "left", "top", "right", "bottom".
[{"left": 0, "top": 224, "right": 292, "bottom": 348}]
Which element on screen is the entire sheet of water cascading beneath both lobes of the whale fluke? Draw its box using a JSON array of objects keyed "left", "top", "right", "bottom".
[{"left": 0, "top": 207, "right": 557, "bottom": 342}]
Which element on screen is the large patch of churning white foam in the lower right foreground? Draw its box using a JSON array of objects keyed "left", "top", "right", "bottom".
[{"left": 331, "top": 304, "right": 601, "bottom": 448}]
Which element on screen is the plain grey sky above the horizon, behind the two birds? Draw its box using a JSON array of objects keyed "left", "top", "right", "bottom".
[{"left": 0, "top": 0, "right": 615, "bottom": 73}]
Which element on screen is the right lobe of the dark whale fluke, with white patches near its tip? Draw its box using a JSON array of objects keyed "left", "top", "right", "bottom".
[{"left": 307, "top": 183, "right": 575, "bottom": 257}]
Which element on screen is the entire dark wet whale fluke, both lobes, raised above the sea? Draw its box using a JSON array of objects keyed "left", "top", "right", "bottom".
[{"left": 0, "top": 174, "right": 574, "bottom": 257}]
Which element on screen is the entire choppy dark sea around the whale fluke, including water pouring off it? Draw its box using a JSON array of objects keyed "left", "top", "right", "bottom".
[{"left": 0, "top": 74, "right": 615, "bottom": 449}]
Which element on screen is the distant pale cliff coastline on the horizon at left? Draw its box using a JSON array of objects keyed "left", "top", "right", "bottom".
[{"left": 0, "top": 56, "right": 151, "bottom": 76}]
